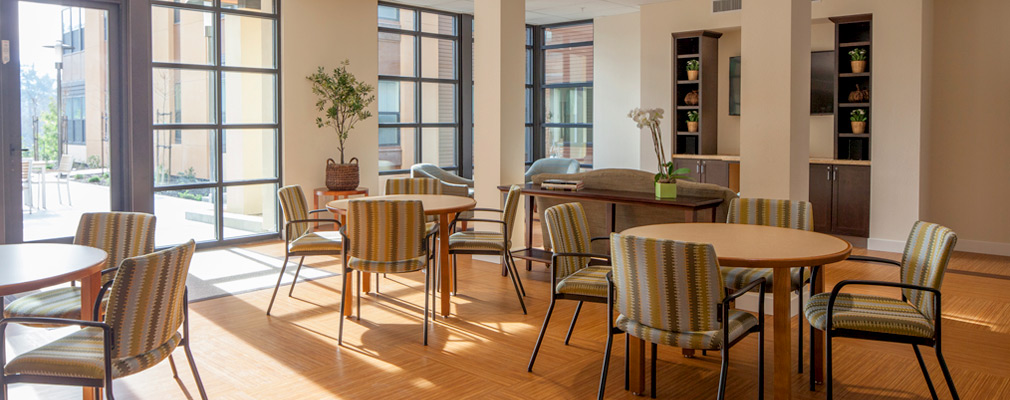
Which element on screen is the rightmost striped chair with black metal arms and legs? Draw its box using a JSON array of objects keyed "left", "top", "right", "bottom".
[{"left": 803, "top": 221, "right": 958, "bottom": 399}]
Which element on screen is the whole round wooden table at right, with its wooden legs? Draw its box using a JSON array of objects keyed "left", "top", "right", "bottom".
[{"left": 621, "top": 223, "right": 852, "bottom": 399}]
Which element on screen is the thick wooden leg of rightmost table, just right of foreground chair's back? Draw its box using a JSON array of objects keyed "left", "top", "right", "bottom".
[{"left": 772, "top": 268, "right": 793, "bottom": 400}]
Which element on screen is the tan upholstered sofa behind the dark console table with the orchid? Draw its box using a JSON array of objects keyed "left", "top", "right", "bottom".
[{"left": 533, "top": 169, "right": 737, "bottom": 254}]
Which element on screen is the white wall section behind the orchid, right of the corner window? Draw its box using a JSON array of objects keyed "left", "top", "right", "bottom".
[{"left": 593, "top": 12, "right": 642, "bottom": 169}]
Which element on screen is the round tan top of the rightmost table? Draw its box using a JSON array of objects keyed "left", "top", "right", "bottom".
[{"left": 621, "top": 223, "right": 852, "bottom": 268}]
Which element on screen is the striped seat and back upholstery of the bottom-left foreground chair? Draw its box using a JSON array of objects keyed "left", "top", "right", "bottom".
[{"left": 4, "top": 240, "right": 196, "bottom": 379}]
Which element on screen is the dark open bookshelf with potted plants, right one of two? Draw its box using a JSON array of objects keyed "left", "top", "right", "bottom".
[{"left": 830, "top": 14, "right": 874, "bottom": 161}]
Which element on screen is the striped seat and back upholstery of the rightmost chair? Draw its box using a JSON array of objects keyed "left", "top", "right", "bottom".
[{"left": 804, "top": 221, "right": 957, "bottom": 337}]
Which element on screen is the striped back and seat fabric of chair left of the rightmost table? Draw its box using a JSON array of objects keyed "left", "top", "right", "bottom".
[{"left": 543, "top": 203, "right": 610, "bottom": 297}]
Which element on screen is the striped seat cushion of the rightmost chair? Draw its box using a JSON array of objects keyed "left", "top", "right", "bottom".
[{"left": 803, "top": 293, "right": 933, "bottom": 337}]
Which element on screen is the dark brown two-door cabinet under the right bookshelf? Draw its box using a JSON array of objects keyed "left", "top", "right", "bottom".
[{"left": 810, "top": 164, "right": 870, "bottom": 237}]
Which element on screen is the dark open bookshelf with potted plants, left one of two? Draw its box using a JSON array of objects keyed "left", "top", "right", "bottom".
[{"left": 671, "top": 30, "right": 722, "bottom": 155}]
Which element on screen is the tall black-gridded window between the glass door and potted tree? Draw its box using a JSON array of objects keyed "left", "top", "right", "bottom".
[{"left": 150, "top": 0, "right": 280, "bottom": 245}]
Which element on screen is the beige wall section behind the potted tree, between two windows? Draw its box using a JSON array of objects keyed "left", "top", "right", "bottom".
[{"left": 281, "top": 0, "right": 379, "bottom": 196}]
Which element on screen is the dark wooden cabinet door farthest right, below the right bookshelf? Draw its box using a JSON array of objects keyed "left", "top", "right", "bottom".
[{"left": 831, "top": 166, "right": 870, "bottom": 237}]
